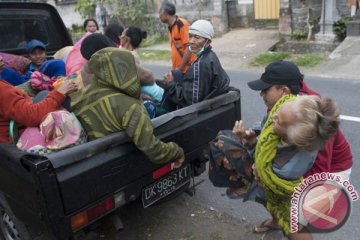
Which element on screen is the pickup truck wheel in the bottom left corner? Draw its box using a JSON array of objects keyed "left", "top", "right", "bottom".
[{"left": 0, "top": 199, "right": 46, "bottom": 240}]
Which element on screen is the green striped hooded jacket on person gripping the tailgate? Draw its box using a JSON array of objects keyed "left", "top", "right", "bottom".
[{"left": 71, "top": 48, "right": 183, "bottom": 164}]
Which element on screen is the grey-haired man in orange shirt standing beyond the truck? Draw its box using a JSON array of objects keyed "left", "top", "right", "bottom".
[{"left": 159, "top": 2, "right": 196, "bottom": 73}]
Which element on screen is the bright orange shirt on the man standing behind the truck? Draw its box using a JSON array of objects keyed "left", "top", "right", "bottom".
[{"left": 168, "top": 17, "right": 196, "bottom": 73}]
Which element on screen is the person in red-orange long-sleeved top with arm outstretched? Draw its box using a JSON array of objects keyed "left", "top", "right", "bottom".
[{"left": 0, "top": 80, "right": 77, "bottom": 144}]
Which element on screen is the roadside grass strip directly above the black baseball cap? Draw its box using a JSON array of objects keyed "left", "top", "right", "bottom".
[{"left": 250, "top": 52, "right": 326, "bottom": 68}]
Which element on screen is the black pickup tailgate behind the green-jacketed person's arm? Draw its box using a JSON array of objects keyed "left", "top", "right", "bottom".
[{"left": 48, "top": 91, "right": 241, "bottom": 214}]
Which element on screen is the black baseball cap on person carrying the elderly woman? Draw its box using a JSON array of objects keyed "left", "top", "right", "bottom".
[{"left": 248, "top": 61, "right": 304, "bottom": 94}]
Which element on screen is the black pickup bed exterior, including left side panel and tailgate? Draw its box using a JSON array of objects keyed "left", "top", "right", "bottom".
[{"left": 0, "top": 91, "right": 241, "bottom": 239}]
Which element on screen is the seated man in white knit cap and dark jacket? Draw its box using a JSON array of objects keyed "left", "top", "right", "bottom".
[{"left": 162, "top": 20, "right": 230, "bottom": 111}]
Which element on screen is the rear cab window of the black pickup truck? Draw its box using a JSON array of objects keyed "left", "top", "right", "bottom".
[{"left": 0, "top": 19, "right": 49, "bottom": 50}]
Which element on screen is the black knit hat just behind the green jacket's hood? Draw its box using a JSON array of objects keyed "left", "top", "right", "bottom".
[{"left": 80, "top": 33, "right": 116, "bottom": 60}]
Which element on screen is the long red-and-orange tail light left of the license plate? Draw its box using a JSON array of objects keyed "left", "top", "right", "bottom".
[{"left": 70, "top": 192, "right": 125, "bottom": 232}]
